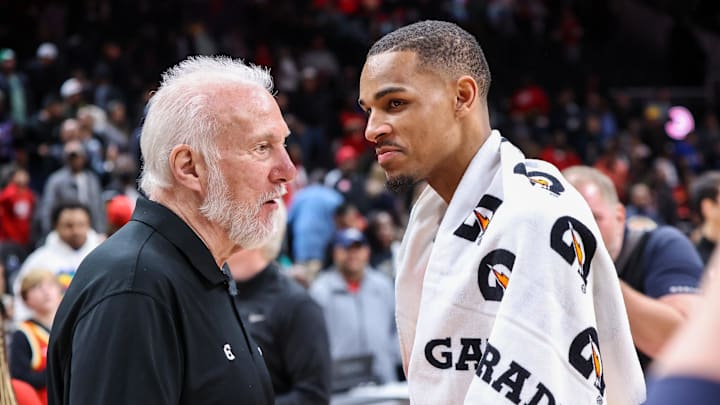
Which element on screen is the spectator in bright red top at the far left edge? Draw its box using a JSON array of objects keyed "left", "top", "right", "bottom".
[{"left": 0, "top": 167, "right": 36, "bottom": 249}]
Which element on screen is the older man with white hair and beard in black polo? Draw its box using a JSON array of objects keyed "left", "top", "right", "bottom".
[{"left": 48, "top": 57, "right": 296, "bottom": 404}]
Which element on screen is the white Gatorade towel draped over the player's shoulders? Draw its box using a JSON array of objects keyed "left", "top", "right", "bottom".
[{"left": 396, "top": 131, "right": 645, "bottom": 405}]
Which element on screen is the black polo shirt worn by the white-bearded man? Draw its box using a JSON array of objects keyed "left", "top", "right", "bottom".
[{"left": 48, "top": 199, "right": 273, "bottom": 405}]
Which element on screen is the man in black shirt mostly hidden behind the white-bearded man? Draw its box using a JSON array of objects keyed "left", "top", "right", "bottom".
[{"left": 227, "top": 202, "right": 330, "bottom": 405}]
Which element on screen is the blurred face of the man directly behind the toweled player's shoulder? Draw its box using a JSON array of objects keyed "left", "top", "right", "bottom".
[{"left": 577, "top": 183, "right": 625, "bottom": 260}]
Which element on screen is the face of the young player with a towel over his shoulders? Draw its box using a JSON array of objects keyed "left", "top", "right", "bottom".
[{"left": 359, "top": 51, "right": 462, "bottom": 193}]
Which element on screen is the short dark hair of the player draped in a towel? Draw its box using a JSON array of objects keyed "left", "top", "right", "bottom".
[{"left": 367, "top": 20, "right": 490, "bottom": 97}]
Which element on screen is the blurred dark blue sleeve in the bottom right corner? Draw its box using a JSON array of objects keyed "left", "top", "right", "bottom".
[{"left": 645, "top": 377, "right": 720, "bottom": 405}]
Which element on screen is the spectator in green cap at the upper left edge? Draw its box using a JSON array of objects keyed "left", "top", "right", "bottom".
[{"left": 0, "top": 48, "right": 32, "bottom": 129}]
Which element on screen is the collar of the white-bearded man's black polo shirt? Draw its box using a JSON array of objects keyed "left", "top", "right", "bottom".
[{"left": 131, "top": 198, "right": 227, "bottom": 284}]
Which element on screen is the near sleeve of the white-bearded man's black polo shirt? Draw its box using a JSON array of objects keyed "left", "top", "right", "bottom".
[{"left": 69, "top": 292, "right": 184, "bottom": 405}]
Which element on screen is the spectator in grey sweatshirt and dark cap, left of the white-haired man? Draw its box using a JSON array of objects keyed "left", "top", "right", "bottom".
[{"left": 40, "top": 140, "right": 106, "bottom": 234}]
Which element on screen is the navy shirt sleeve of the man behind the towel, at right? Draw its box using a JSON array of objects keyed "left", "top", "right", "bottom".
[{"left": 643, "top": 226, "right": 703, "bottom": 298}]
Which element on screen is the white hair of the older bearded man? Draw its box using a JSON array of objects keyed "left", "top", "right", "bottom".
[{"left": 140, "top": 56, "right": 273, "bottom": 198}]
